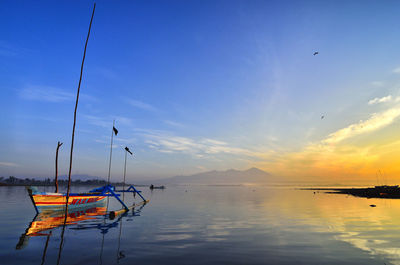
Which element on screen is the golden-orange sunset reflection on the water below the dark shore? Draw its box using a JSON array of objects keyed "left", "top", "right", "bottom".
[{"left": 266, "top": 189, "right": 400, "bottom": 264}]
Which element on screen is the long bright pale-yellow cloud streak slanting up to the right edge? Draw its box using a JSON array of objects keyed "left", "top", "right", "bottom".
[{"left": 322, "top": 107, "right": 400, "bottom": 144}]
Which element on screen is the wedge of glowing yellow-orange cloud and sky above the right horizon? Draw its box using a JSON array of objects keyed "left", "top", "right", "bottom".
[{"left": 255, "top": 103, "right": 400, "bottom": 185}]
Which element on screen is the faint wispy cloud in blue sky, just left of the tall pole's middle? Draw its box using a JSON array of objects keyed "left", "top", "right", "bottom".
[{"left": 19, "top": 86, "right": 75, "bottom": 103}]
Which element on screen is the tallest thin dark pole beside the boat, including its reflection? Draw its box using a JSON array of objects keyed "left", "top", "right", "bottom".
[{"left": 57, "top": 3, "right": 96, "bottom": 265}]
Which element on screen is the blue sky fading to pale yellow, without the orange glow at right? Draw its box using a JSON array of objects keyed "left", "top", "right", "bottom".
[{"left": 0, "top": 1, "right": 400, "bottom": 180}]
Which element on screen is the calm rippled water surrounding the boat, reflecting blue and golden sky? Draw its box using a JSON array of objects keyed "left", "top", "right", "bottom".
[{"left": 0, "top": 186, "right": 400, "bottom": 265}]
